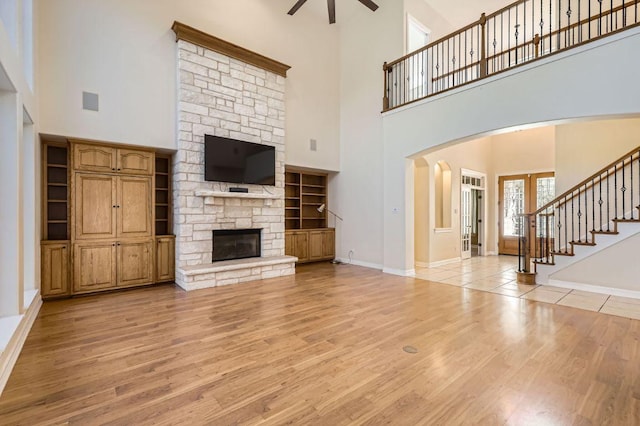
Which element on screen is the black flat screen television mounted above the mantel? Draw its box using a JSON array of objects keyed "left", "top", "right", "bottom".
[{"left": 204, "top": 135, "right": 276, "bottom": 185}]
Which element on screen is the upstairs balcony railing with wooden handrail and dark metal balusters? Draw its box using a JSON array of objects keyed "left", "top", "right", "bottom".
[{"left": 383, "top": 0, "right": 640, "bottom": 111}]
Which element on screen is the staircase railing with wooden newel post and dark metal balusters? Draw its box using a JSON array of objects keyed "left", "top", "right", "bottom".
[{"left": 518, "top": 147, "right": 640, "bottom": 272}]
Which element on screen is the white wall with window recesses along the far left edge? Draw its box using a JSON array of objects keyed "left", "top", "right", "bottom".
[{"left": 0, "top": 0, "right": 40, "bottom": 393}]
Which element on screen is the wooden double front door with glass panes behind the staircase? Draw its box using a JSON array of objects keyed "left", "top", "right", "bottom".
[{"left": 498, "top": 172, "right": 555, "bottom": 255}]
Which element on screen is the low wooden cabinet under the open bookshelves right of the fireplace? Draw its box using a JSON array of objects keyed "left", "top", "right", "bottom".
[{"left": 285, "top": 228, "right": 335, "bottom": 263}]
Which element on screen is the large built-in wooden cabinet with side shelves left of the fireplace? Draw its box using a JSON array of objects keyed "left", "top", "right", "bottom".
[{"left": 42, "top": 140, "right": 175, "bottom": 297}]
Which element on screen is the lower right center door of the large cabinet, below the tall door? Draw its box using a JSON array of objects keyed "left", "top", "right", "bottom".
[{"left": 117, "top": 240, "right": 153, "bottom": 287}]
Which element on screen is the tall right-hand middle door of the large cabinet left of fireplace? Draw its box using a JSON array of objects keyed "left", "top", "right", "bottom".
[{"left": 116, "top": 176, "right": 153, "bottom": 238}]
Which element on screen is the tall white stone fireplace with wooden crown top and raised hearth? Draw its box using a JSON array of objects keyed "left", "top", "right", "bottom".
[{"left": 173, "top": 23, "right": 297, "bottom": 290}]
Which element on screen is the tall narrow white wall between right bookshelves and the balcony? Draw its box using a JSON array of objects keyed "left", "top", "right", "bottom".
[{"left": 332, "top": 2, "right": 403, "bottom": 266}]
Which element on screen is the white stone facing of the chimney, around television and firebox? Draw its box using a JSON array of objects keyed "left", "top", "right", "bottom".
[{"left": 173, "top": 40, "right": 285, "bottom": 287}]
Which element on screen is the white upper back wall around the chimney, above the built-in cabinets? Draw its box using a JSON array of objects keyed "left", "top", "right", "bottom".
[{"left": 38, "top": 0, "right": 340, "bottom": 170}]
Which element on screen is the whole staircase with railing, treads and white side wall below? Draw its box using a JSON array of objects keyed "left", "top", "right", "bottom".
[{"left": 519, "top": 147, "right": 640, "bottom": 297}]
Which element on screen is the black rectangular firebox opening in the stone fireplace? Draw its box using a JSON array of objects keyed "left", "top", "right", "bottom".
[{"left": 213, "top": 229, "right": 262, "bottom": 262}]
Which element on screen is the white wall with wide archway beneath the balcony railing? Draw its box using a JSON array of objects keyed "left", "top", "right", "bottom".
[{"left": 383, "top": 28, "right": 640, "bottom": 271}]
